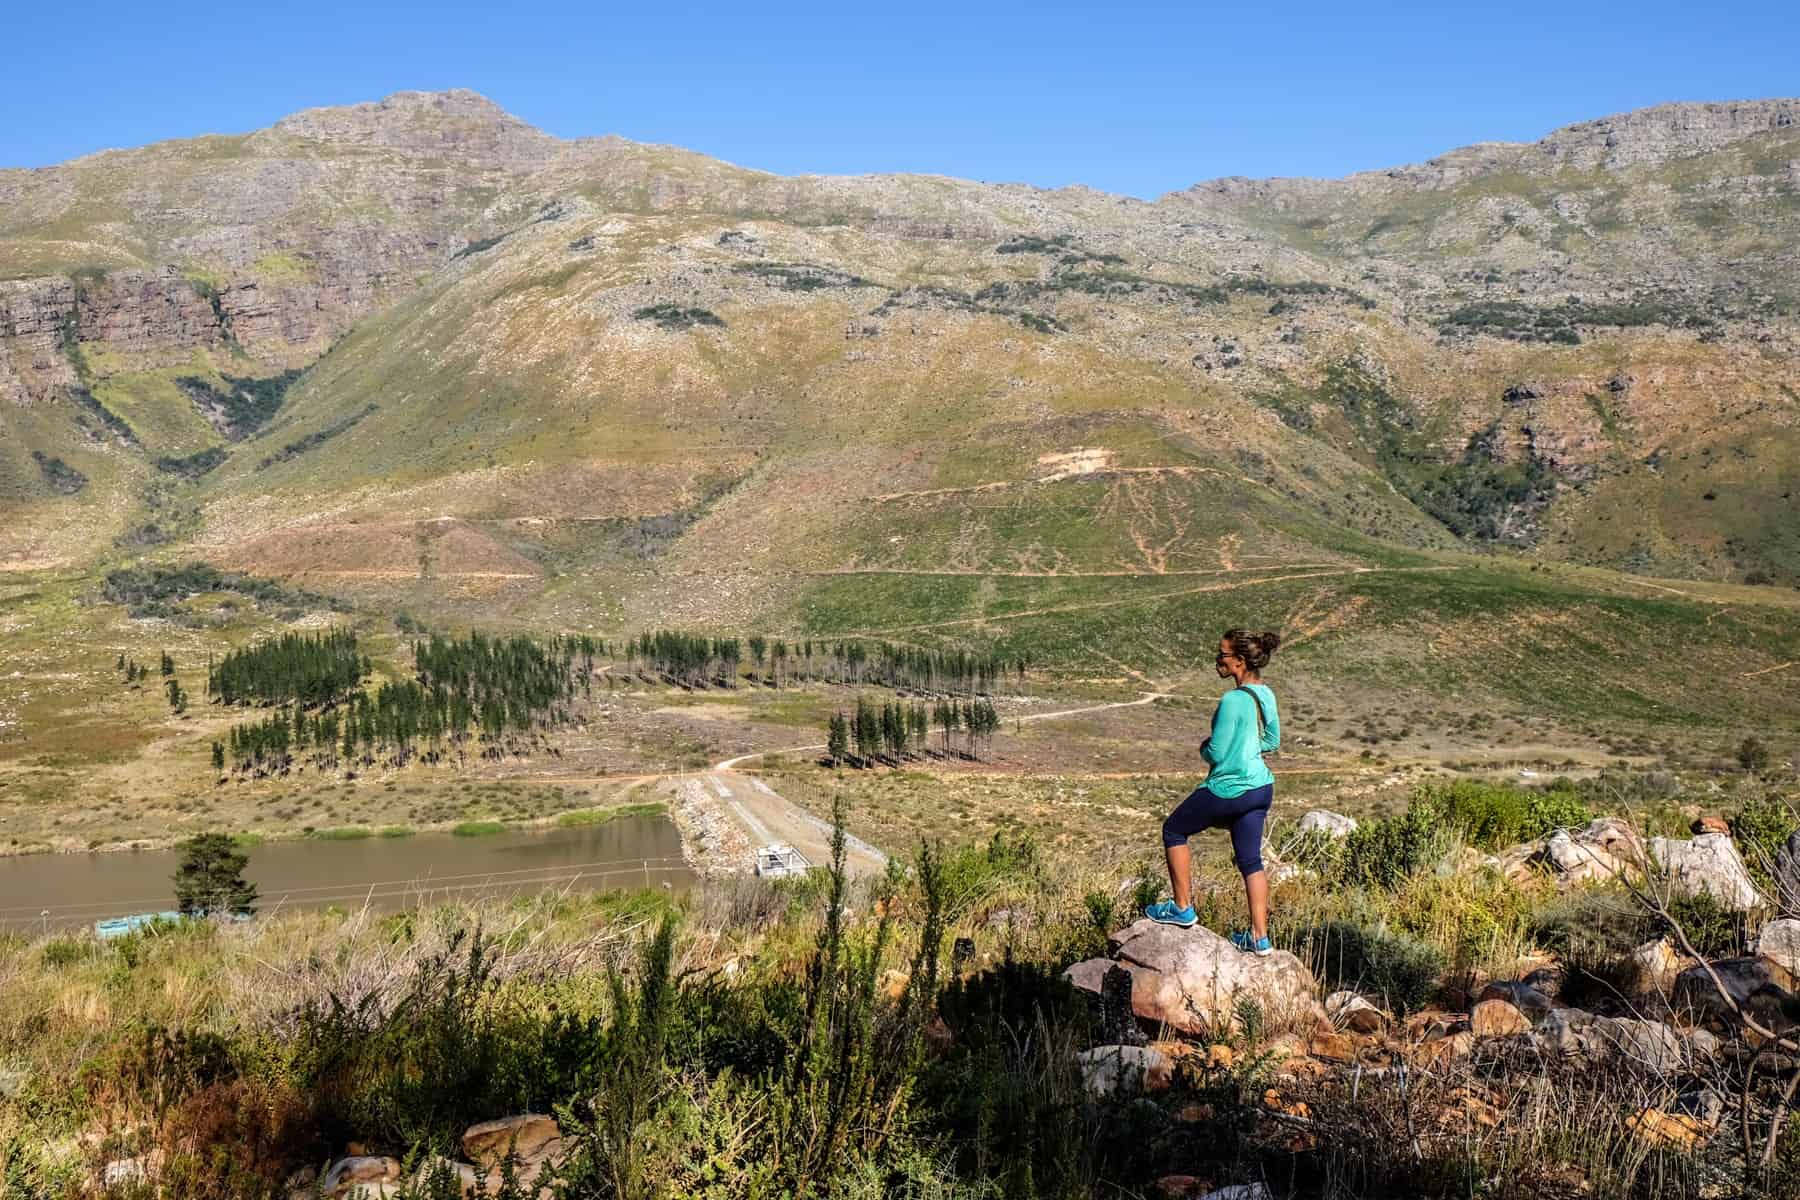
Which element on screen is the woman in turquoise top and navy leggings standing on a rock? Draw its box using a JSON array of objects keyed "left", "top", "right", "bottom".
[{"left": 1145, "top": 630, "right": 1282, "bottom": 955}]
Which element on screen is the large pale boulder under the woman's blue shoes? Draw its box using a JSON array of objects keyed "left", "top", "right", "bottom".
[{"left": 1064, "top": 919, "right": 1318, "bottom": 1034}]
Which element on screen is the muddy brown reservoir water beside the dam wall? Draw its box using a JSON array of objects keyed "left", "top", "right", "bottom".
[{"left": 0, "top": 815, "right": 693, "bottom": 932}]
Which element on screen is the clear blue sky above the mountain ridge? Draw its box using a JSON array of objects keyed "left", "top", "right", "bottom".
[{"left": 0, "top": 0, "right": 1800, "bottom": 196}]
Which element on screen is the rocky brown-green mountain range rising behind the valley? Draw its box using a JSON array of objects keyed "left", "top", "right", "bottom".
[{"left": 0, "top": 92, "right": 1800, "bottom": 676}]
